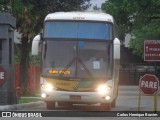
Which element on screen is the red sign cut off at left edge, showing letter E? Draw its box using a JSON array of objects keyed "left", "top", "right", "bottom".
[{"left": 0, "top": 66, "right": 7, "bottom": 87}]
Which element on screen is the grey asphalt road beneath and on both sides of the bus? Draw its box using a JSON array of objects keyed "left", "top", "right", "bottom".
[{"left": 15, "top": 86, "right": 160, "bottom": 112}]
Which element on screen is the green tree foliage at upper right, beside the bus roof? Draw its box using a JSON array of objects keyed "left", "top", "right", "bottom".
[{"left": 102, "top": 0, "right": 160, "bottom": 57}]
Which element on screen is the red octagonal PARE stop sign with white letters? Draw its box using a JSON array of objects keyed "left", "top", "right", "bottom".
[{"left": 139, "top": 74, "right": 159, "bottom": 95}]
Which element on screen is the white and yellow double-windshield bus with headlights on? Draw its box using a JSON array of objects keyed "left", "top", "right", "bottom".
[{"left": 32, "top": 12, "right": 120, "bottom": 110}]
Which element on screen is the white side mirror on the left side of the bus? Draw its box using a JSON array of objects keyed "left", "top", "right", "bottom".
[{"left": 31, "top": 35, "right": 41, "bottom": 55}]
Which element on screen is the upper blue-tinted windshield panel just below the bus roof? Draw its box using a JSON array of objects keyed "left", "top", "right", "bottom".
[{"left": 44, "top": 21, "right": 113, "bottom": 40}]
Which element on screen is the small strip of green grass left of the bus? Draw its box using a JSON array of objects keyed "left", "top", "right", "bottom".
[{"left": 19, "top": 97, "right": 41, "bottom": 103}]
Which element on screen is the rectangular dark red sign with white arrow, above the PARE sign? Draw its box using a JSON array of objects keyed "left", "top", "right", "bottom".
[{"left": 144, "top": 40, "right": 160, "bottom": 61}]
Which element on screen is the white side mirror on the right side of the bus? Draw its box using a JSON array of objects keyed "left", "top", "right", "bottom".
[{"left": 113, "top": 38, "right": 120, "bottom": 59}]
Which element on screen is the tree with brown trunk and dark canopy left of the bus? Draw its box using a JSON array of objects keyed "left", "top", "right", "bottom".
[{"left": 0, "top": 0, "right": 90, "bottom": 94}]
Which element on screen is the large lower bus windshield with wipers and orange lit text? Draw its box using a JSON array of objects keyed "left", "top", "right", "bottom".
[{"left": 42, "top": 39, "right": 112, "bottom": 78}]
